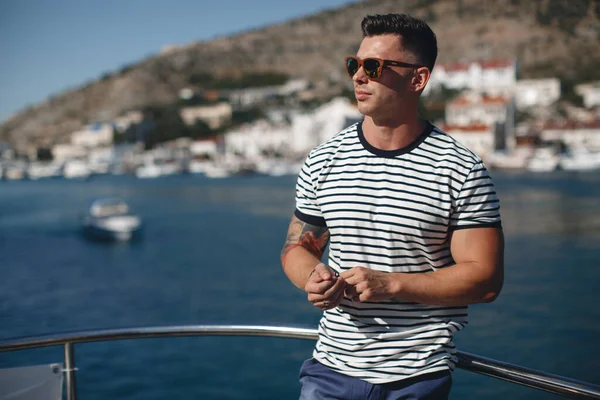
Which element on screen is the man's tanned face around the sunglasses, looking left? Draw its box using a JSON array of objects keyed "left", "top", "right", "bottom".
[{"left": 352, "top": 35, "right": 416, "bottom": 118}]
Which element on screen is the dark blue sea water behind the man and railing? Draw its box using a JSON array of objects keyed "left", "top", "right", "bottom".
[{"left": 0, "top": 172, "right": 600, "bottom": 400}]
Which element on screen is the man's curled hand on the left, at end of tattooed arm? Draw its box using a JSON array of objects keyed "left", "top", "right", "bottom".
[{"left": 304, "top": 263, "right": 346, "bottom": 310}]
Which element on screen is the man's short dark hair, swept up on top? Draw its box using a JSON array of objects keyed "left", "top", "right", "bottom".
[{"left": 361, "top": 14, "right": 437, "bottom": 71}]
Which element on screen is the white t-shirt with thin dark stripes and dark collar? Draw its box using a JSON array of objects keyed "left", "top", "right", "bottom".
[{"left": 295, "top": 123, "right": 500, "bottom": 384}]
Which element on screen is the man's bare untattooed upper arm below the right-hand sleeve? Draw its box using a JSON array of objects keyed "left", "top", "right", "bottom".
[{"left": 450, "top": 227, "right": 504, "bottom": 300}]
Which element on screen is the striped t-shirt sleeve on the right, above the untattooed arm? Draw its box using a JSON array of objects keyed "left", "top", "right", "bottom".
[{"left": 450, "top": 162, "right": 502, "bottom": 230}]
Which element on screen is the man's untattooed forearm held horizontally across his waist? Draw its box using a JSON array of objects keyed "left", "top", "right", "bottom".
[{"left": 390, "top": 263, "right": 503, "bottom": 306}]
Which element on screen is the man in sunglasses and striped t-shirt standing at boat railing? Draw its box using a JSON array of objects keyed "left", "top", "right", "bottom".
[{"left": 281, "top": 14, "right": 504, "bottom": 399}]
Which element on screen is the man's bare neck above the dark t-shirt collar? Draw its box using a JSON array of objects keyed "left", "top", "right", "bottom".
[{"left": 362, "top": 115, "right": 426, "bottom": 150}]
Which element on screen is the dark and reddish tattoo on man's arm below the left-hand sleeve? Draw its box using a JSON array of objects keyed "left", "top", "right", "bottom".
[{"left": 281, "top": 217, "right": 329, "bottom": 264}]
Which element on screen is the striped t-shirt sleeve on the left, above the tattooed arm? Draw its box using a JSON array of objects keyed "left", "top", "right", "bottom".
[{"left": 294, "top": 155, "right": 327, "bottom": 226}]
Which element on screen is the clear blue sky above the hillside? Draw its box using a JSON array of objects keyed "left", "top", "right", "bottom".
[{"left": 0, "top": 0, "right": 357, "bottom": 122}]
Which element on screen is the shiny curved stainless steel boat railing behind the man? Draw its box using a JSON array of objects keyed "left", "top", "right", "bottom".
[{"left": 0, "top": 325, "right": 600, "bottom": 400}]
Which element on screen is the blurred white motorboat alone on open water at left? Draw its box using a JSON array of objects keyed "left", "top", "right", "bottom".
[{"left": 81, "top": 198, "right": 142, "bottom": 241}]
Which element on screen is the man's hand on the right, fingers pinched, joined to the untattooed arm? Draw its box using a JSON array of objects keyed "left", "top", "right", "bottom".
[{"left": 340, "top": 267, "right": 394, "bottom": 302}]
